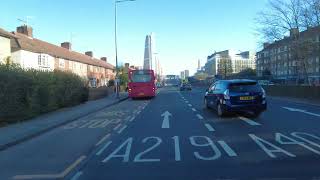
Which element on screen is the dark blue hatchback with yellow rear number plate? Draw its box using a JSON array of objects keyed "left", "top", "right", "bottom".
[{"left": 204, "top": 80, "right": 267, "bottom": 116}]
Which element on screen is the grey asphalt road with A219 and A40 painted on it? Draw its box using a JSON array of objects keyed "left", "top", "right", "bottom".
[{"left": 0, "top": 87, "right": 320, "bottom": 180}]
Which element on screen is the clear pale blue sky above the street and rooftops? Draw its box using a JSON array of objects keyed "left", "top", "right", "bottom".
[{"left": 0, "top": 0, "right": 267, "bottom": 74}]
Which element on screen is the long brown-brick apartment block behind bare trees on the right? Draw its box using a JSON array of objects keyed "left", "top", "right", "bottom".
[{"left": 257, "top": 26, "right": 320, "bottom": 85}]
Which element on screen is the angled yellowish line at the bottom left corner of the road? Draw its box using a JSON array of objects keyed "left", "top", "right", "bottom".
[{"left": 13, "top": 156, "right": 86, "bottom": 179}]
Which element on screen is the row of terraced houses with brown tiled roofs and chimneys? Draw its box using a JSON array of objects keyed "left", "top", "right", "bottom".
[{"left": 0, "top": 25, "right": 115, "bottom": 87}]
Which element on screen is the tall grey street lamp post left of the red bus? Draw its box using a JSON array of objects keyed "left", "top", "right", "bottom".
[{"left": 114, "top": 0, "right": 136, "bottom": 99}]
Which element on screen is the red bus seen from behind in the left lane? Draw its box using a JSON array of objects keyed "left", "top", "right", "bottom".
[{"left": 128, "top": 70, "right": 156, "bottom": 98}]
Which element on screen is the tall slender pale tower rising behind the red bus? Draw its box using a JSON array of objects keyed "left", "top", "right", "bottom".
[{"left": 143, "top": 33, "right": 157, "bottom": 69}]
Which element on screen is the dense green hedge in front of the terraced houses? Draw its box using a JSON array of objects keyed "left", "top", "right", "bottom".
[{"left": 0, "top": 64, "right": 89, "bottom": 123}]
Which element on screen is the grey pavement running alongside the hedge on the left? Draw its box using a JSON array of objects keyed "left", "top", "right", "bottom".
[{"left": 0, "top": 93, "right": 128, "bottom": 150}]
